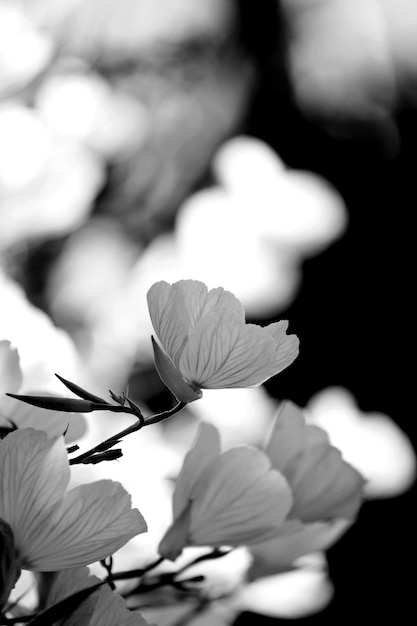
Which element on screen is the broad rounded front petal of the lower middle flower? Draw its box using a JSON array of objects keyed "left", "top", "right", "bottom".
[{"left": 190, "top": 447, "right": 292, "bottom": 546}]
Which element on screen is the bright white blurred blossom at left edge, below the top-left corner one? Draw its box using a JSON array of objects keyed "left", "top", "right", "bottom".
[{"left": 0, "top": 103, "right": 104, "bottom": 249}]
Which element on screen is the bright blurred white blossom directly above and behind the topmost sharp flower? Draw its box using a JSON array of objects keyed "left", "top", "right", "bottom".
[{"left": 132, "top": 137, "right": 347, "bottom": 317}]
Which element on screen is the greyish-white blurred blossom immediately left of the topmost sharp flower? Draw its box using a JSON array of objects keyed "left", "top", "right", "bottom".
[{"left": 47, "top": 217, "right": 141, "bottom": 389}]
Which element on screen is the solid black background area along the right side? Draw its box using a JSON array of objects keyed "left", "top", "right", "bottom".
[{"left": 236, "top": 70, "right": 417, "bottom": 626}]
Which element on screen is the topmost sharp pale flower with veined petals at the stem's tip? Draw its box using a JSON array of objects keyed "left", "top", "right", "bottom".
[{"left": 148, "top": 280, "right": 299, "bottom": 402}]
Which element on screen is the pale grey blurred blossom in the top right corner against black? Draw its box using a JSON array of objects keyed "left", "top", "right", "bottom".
[{"left": 281, "top": 0, "right": 417, "bottom": 141}]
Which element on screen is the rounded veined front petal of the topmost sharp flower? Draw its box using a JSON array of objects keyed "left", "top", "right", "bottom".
[{"left": 179, "top": 314, "right": 277, "bottom": 389}]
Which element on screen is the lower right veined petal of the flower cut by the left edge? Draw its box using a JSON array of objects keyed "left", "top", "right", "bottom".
[{"left": 24, "top": 480, "right": 147, "bottom": 572}]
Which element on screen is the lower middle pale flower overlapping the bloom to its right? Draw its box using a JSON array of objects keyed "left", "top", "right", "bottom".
[{"left": 159, "top": 423, "right": 293, "bottom": 560}]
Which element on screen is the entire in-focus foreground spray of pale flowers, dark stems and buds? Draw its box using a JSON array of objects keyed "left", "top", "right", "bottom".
[{"left": 0, "top": 280, "right": 364, "bottom": 626}]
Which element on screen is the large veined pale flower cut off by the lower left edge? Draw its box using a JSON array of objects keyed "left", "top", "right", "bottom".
[{"left": 0, "top": 428, "right": 146, "bottom": 572}]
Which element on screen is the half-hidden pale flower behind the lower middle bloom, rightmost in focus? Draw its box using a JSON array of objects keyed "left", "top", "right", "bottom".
[{"left": 251, "top": 402, "right": 365, "bottom": 578}]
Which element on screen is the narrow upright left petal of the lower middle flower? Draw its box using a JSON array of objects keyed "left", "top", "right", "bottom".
[{"left": 173, "top": 423, "right": 220, "bottom": 518}]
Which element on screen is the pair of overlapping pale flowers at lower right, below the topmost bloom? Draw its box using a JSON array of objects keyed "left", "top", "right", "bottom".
[{"left": 159, "top": 403, "right": 364, "bottom": 571}]
